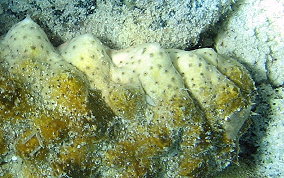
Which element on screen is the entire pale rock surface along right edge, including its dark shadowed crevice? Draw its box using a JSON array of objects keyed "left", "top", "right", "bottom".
[{"left": 214, "top": 0, "right": 284, "bottom": 177}]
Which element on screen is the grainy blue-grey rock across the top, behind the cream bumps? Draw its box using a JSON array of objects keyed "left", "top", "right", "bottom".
[{"left": 0, "top": 0, "right": 234, "bottom": 49}]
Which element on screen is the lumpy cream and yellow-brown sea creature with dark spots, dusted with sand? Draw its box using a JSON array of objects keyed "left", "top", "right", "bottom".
[{"left": 0, "top": 18, "right": 254, "bottom": 177}]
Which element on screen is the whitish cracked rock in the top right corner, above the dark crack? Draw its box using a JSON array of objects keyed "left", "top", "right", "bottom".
[{"left": 216, "top": 0, "right": 284, "bottom": 86}]
